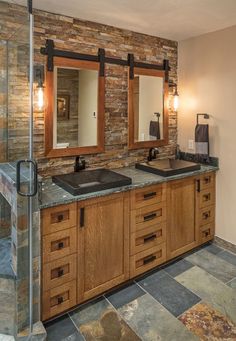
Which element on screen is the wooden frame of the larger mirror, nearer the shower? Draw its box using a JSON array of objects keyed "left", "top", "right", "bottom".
[{"left": 45, "top": 57, "right": 105, "bottom": 157}]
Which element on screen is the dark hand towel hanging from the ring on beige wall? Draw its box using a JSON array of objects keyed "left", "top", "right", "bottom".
[{"left": 195, "top": 124, "right": 209, "bottom": 155}]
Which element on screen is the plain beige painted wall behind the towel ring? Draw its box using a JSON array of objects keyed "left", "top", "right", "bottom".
[{"left": 178, "top": 26, "right": 236, "bottom": 244}]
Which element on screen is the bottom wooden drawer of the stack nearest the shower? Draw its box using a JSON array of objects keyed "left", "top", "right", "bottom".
[{"left": 42, "top": 281, "right": 76, "bottom": 321}]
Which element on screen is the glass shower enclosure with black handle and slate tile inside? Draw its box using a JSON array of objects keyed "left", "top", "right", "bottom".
[{"left": 0, "top": 0, "right": 39, "bottom": 339}]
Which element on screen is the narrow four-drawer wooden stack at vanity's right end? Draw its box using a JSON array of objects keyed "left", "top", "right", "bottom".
[{"left": 199, "top": 173, "right": 215, "bottom": 244}]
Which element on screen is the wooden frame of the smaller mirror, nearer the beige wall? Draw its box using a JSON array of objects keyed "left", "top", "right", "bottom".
[{"left": 128, "top": 67, "right": 169, "bottom": 149}]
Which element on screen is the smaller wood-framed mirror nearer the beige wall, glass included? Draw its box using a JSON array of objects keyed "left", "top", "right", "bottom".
[{"left": 128, "top": 67, "right": 168, "bottom": 149}]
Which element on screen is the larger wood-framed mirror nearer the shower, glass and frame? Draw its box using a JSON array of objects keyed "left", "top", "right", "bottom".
[{"left": 45, "top": 57, "right": 105, "bottom": 157}]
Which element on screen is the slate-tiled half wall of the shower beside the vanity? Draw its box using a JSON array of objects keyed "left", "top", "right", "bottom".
[{"left": 0, "top": 164, "right": 40, "bottom": 335}]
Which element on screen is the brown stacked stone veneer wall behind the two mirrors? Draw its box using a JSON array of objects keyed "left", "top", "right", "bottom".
[{"left": 0, "top": 2, "right": 177, "bottom": 176}]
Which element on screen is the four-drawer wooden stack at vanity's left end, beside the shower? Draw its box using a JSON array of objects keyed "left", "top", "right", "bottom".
[{"left": 41, "top": 203, "right": 77, "bottom": 320}]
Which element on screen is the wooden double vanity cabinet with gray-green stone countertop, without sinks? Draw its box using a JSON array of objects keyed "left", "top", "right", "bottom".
[{"left": 41, "top": 166, "right": 216, "bottom": 320}]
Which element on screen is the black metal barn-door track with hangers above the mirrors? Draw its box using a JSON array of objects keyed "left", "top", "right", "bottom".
[{"left": 40, "top": 39, "right": 170, "bottom": 76}]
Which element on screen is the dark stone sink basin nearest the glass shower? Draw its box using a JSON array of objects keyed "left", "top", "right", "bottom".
[{"left": 52, "top": 168, "right": 132, "bottom": 195}]
